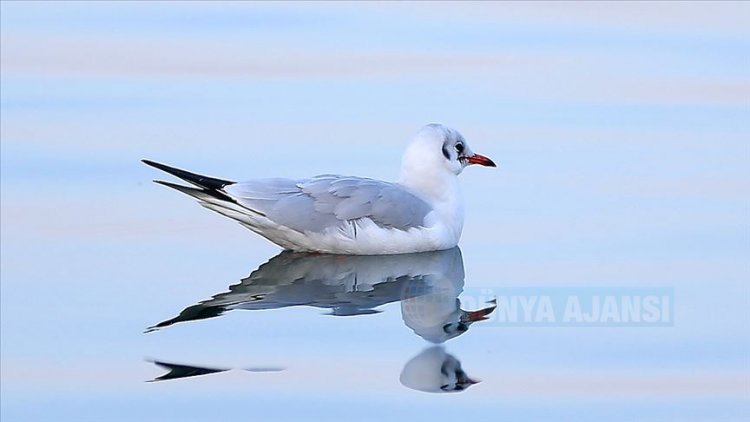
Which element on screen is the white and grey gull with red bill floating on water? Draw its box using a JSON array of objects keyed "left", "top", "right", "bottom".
[{"left": 143, "top": 124, "right": 495, "bottom": 255}]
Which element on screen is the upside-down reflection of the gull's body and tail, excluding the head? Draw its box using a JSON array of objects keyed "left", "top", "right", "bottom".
[{"left": 146, "top": 247, "right": 464, "bottom": 332}]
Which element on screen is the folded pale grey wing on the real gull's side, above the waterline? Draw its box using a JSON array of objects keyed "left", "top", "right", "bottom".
[{"left": 224, "top": 175, "right": 432, "bottom": 232}]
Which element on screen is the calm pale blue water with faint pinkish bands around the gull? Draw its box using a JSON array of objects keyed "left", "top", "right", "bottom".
[{"left": 0, "top": 2, "right": 750, "bottom": 422}]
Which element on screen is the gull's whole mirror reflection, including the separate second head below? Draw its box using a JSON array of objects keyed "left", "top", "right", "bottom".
[{"left": 147, "top": 247, "right": 495, "bottom": 392}]
